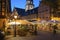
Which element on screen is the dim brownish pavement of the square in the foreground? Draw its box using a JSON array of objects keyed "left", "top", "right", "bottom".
[{"left": 6, "top": 31, "right": 60, "bottom": 40}]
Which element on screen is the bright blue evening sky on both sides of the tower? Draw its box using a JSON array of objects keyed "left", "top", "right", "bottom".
[{"left": 11, "top": 0, "right": 39, "bottom": 10}]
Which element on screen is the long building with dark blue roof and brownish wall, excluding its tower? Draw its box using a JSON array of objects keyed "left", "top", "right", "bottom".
[{"left": 12, "top": 7, "right": 38, "bottom": 20}]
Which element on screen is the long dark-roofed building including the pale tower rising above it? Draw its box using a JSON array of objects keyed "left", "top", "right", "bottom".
[{"left": 13, "top": 0, "right": 38, "bottom": 20}]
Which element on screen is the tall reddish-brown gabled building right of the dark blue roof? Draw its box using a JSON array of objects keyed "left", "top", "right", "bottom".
[{"left": 38, "top": 1, "right": 51, "bottom": 20}]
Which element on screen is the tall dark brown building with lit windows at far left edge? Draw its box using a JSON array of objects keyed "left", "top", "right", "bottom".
[{"left": 0, "top": 0, "right": 11, "bottom": 17}]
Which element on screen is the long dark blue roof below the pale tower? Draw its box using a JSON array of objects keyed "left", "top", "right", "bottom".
[{"left": 14, "top": 7, "right": 38, "bottom": 16}]
